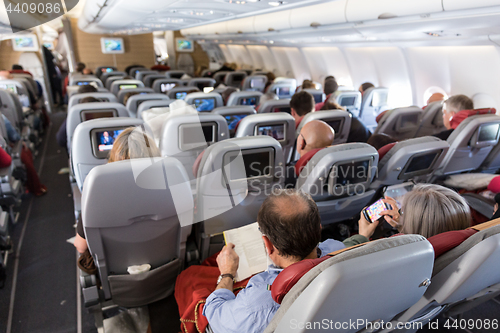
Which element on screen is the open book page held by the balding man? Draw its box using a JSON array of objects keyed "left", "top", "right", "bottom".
[{"left": 224, "top": 222, "right": 267, "bottom": 281}]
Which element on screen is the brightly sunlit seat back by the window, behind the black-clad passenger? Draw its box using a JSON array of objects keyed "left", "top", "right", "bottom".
[{"left": 358, "top": 87, "right": 389, "bottom": 132}]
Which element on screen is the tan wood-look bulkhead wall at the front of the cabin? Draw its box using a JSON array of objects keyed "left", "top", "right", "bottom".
[{"left": 71, "top": 18, "right": 155, "bottom": 70}]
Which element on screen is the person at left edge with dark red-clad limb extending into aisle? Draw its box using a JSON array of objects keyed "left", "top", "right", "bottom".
[{"left": 2, "top": 115, "right": 47, "bottom": 197}]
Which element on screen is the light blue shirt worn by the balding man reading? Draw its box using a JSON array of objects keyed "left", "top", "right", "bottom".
[{"left": 203, "top": 239, "right": 345, "bottom": 333}]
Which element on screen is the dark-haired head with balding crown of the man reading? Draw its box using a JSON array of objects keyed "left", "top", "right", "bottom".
[{"left": 257, "top": 189, "right": 321, "bottom": 260}]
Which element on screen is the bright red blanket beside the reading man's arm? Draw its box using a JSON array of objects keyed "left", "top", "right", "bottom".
[{"left": 175, "top": 253, "right": 250, "bottom": 333}]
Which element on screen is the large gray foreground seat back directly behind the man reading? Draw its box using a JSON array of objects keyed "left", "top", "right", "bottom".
[{"left": 264, "top": 235, "right": 434, "bottom": 333}]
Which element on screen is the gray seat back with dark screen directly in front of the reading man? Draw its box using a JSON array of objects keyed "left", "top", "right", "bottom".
[{"left": 196, "top": 136, "right": 284, "bottom": 240}]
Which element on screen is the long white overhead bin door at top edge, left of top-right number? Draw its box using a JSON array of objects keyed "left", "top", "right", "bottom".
[{"left": 346, "top": 0, "right": 444, "bottom": 22}]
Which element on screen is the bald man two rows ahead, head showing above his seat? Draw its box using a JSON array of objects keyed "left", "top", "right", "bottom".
[{"left": 285, "top": 120, "right": 335, "bottom": 188}]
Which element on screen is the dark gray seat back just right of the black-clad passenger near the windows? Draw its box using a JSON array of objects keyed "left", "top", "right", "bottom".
[{"left": 373, "top": 106, "right": 424, "bottom": 141}]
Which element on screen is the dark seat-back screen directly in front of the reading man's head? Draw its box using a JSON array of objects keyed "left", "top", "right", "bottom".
[{"left": 229, "top": 148, "right": 273, "bottom": 180}]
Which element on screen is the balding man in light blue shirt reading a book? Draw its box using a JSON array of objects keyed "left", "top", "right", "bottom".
[{"left": 203, "top": 189, "right": 344, "bottom": 333}]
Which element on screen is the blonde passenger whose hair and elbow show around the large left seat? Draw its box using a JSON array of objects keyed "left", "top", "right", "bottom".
[{"left": 74, "top": 127, "right": 160, "bottom": 258}]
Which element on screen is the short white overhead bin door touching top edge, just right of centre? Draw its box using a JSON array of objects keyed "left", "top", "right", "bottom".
[{"left": 290, "top": 0, "right": 347, "bottom": 29}]
